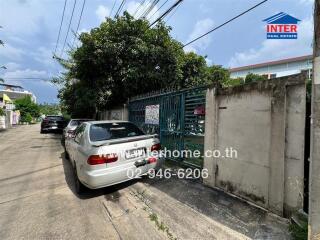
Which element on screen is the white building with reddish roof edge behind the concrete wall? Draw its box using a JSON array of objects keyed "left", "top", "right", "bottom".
[{"left": 229, "top": 55, "right": 312, "bottom": 79}]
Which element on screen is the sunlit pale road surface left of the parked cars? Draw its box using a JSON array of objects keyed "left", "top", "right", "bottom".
[{"left": 0, "top": 124, "right": 134, "bottom": 239}]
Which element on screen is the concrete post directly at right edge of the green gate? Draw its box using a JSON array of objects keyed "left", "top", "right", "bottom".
[{"left": 203, "top": 88, "right": 218, "bottom": 187}]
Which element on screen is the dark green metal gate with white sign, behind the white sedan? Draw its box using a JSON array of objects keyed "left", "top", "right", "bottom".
[{"left": 129, "top": 87, "right": 207, "bottom": 167}]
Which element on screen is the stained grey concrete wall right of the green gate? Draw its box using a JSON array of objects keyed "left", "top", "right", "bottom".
[{"left": 204, "top": 73, "right": 306, "bottom": 216}]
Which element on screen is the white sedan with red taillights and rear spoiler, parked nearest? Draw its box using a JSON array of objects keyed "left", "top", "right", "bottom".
[{"left": 65, "top": 121, "right": 163, "bottom": 193}]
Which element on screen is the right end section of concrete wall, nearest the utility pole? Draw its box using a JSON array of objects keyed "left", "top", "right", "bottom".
[{"left": 284, "top": 84, "right": 309, "bottom": 217}]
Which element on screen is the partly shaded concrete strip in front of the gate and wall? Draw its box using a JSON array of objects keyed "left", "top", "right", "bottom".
[{"left": 125, "top": 174, "right": 291, "bottom": 240}]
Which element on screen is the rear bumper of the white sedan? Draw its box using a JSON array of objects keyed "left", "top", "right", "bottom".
[{"left": 79, "top": 158, "right": 164, "bottom": 189}]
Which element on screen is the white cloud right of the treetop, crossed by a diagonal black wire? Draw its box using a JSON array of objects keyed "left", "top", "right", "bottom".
[{"left": 185, "top": 18, "right": 214, "bottom": 52}]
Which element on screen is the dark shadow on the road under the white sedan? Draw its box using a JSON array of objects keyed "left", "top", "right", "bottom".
[{"left": 61, "top": 153, "right": 136, "bottom": 199}]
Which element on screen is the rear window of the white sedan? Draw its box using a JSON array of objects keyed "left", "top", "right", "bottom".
[{"left": 89, "top": 123, "right": 144, "bottom": 142}]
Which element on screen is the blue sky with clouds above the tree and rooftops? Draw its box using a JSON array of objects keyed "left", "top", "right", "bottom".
[{"left": 0, "top": 0, "right": 314, "bottom": 103}]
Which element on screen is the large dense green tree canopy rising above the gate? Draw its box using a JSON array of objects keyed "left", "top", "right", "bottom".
[{"left": 53, "top": 13, "right": 235, "bottom": 117}]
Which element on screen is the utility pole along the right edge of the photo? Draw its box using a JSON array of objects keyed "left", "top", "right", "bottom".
[{"left": 308, "top": 0, "right": 320, "bottom": 240}]
